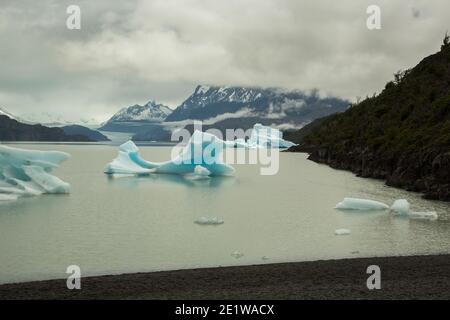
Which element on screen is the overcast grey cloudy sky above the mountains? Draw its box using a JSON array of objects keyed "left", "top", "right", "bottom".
[{"left": 0, "top": 0, "right": 450, "bottom": 120}]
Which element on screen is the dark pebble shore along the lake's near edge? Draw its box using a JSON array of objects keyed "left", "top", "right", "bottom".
[{"left": 0, "top": 255, "right": 450, "bottom": 300}]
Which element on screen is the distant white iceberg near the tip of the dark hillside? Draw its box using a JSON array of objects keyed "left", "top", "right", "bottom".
[{"left": 244, "top": 123, "right": 296, "bottom": 148}]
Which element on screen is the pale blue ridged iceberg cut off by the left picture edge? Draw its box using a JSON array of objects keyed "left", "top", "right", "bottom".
[{"left": 0, "top": 145, "right": 70, "bottom": 201}]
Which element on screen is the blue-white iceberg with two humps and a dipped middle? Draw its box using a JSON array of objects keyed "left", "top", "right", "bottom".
[{"left": 105, "top": 130, "right": 234, "bottom": 178}]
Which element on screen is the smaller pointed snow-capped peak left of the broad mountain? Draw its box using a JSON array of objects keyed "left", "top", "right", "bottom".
[{"left": 108, "top": 101, "right": 172, "bottom": 122}]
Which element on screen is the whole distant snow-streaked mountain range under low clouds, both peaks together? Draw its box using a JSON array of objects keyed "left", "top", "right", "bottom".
[{"left": 99, "top": 85, "right": 349, "bottom": 140}]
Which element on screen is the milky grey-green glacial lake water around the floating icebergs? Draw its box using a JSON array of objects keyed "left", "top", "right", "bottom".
[{"left": 0, "top": 144, "right": 450, "bottom": 283}]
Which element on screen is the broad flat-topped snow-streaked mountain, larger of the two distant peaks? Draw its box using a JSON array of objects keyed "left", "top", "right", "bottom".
[{"left": 166, "top": 85, "right": 349, "bottom": 127}]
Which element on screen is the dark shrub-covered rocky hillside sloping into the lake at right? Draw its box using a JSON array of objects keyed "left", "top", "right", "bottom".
[{"left": 289, "top": 41, "right": 450, "bottom": 201}]
